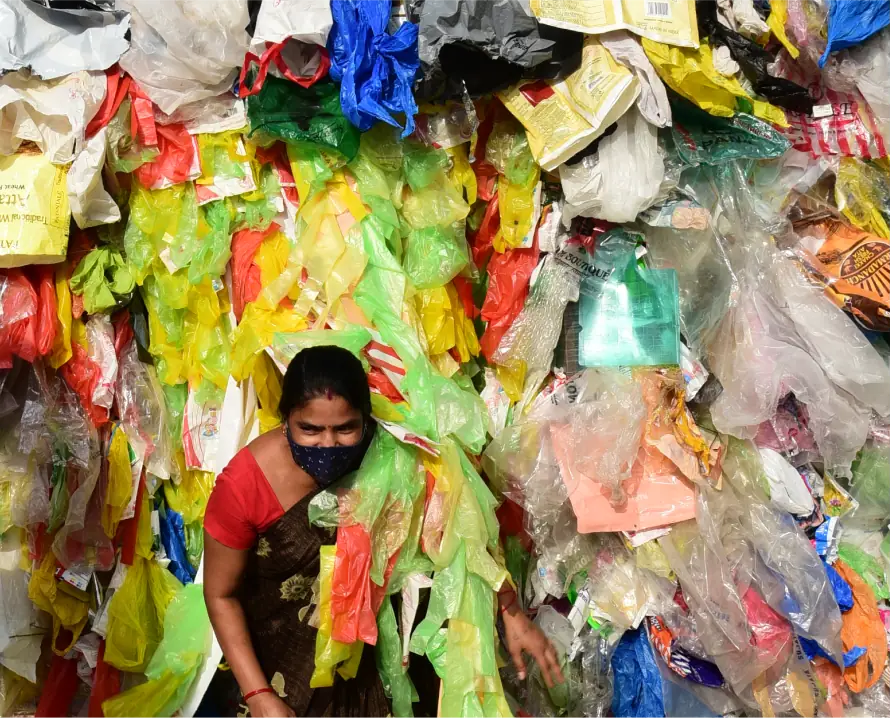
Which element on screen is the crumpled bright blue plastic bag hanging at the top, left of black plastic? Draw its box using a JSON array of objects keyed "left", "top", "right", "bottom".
[{"left": 328, "top": 0, "right": 420, "bottom": 138}]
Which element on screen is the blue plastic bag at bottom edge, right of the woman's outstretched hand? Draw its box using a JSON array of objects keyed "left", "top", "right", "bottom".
[{"left": 612, "top": 624, "right": 665, "bottom": 718}]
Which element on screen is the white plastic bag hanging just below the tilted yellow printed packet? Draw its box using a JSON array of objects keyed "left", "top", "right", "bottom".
[{"left": 596, "top": 109, "right": 665, "bottom": 222}]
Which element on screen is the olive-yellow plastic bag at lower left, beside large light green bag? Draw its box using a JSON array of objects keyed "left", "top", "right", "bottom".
[{"left": 105, "top": 556, "right": 182, "bottom": 673}]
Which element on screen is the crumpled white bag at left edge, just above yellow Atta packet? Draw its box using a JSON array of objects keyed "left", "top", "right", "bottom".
[{"left": 0, "top": 70, "right": 106, "bottom": 164}]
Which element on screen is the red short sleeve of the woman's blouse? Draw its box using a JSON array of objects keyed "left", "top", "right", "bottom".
[{"left": 204, "top": 447, "right": 285, "bottom": 551}]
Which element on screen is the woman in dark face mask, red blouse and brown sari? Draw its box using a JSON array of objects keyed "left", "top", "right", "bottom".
[{"left": 204, "top": 346, "right": 562, "bottom": 718}]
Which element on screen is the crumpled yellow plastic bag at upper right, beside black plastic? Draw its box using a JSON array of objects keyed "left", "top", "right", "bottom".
[{"left": 641, "top": 39, "right": 789, "bottom": 127}]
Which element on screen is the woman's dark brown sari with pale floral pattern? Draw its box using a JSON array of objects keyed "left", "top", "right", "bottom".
[{"left": 240, "top": 492, "right": 390, "bottom": 718}]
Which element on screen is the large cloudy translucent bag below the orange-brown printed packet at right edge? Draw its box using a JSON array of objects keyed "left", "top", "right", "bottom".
[{"left": 709, "top": 243, "right": 891, "bottom": 475}]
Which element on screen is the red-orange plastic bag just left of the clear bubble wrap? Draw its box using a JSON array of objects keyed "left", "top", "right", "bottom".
[{"left": 480, "top": 239, "right": 538, "bottom": 359}]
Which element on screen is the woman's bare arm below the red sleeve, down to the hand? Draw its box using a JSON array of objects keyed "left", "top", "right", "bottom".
[{"left": 204, "top": 531, "right": 294, "bottom": 718}]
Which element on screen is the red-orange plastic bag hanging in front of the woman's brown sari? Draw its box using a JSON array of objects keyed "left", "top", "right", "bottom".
[{"left": 331, "top": 524, "right": 377, "bottom": 646}]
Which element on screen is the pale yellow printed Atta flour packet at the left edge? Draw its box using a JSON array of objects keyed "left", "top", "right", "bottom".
[{"left": 0, "top": 152, "right": 71, "bottom": 267}]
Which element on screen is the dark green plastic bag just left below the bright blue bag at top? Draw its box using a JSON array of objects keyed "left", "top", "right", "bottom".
[{"left": 247, "top": 76, "right": 359, "bottom": 162}]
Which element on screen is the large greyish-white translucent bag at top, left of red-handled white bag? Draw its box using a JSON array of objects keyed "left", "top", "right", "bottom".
[{"left": 118, "top": 0, "right": 248, "bottom": 114}]
